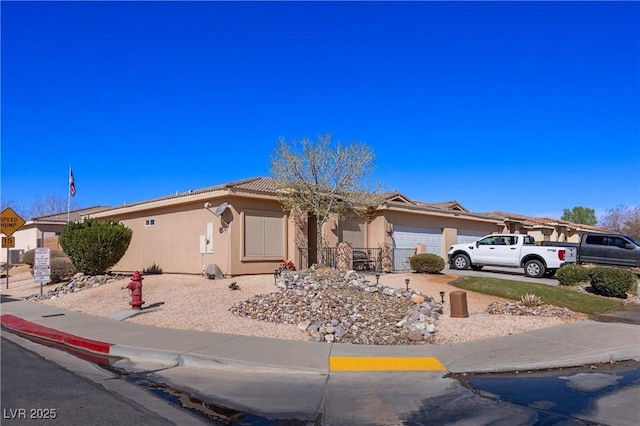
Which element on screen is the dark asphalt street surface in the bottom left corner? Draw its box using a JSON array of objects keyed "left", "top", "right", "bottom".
[{"left": 1, "top": 331, "right": 209, "bottom": 426}]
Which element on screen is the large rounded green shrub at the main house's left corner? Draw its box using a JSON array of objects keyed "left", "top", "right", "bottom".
[{"left": 60, "top": 218, "right": 133, "bottom": 275}]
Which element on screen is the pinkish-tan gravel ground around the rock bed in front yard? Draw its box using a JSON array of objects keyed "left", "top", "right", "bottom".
[{"left": 2, "top": 270, "right": 586, "bottom": 344}]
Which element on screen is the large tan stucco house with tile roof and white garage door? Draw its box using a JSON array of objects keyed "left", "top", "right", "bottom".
[{"left": 92, "top": 177, "right": 502, "bottom": 276}]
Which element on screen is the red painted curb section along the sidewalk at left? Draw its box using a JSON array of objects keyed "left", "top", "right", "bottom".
[{"left": 0, "top": 314, "right": 113, "bottom": 354}]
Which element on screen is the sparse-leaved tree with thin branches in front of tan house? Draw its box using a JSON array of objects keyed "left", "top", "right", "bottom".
[{"left": 271, "top": 135, "right": 383, "bottom": 263}]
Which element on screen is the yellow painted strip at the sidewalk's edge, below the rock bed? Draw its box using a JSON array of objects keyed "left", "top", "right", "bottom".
[{"left": 329, "top": 356, "right": 446, "bottom": 371}]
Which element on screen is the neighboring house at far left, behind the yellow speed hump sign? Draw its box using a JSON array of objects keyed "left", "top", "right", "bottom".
[{"left": 0, "top": 206, "right": 108, "bottom": 264}]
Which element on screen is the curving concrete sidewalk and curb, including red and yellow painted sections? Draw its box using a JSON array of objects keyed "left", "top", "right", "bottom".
[{"left": 0, "top": 296, "right": 640, "bottom": 374}]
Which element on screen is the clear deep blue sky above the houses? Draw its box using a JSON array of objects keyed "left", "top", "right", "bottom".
[{"left": 0, "top": 1, "right": 640, "bottom": 217}]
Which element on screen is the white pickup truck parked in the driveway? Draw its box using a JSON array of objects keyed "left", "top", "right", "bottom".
[{"left": 448, "top": 234, "right": 576, "bottom": 278}]
